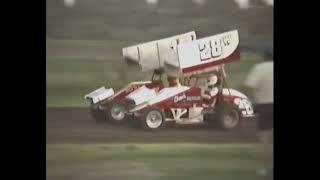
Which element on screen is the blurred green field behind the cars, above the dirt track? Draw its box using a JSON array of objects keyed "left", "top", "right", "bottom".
[{"left": 46, "top": 0, "right": 273, "bottom": 107}]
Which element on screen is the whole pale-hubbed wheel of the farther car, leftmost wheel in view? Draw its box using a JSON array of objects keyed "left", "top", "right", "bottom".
[{"left": 105, "top": 101, "right": 127, "bottom": 124}]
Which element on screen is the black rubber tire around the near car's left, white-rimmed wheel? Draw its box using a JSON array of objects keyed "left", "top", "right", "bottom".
[{"left": 139, "top": 108, "right": 165, "bottom": 131}]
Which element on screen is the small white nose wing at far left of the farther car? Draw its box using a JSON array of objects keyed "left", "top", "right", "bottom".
[{"left": 84, "top": 87, "right": 114, "bottom": 104}]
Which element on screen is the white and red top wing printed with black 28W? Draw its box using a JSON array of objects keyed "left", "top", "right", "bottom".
[{"left": 165, "top": 30, "right": 240, "bottom": 74}]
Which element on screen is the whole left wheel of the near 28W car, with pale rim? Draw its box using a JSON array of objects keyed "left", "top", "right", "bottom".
[{"left": 140, "top": 108, "right": 165, "bottom": 130}]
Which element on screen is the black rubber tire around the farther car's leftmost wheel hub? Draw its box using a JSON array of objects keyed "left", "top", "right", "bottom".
[{"left": 104, "top": 101, "right": 128, "bottom": 124}]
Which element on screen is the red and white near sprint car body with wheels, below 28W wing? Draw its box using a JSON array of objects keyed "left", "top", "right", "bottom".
[{"left": 123, "top": 68, "right": 253, "bottom": 130}]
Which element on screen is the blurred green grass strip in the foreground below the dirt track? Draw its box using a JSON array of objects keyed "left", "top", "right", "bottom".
[{"left": 46, "top": 144, "right": 272, "bottom": 180}]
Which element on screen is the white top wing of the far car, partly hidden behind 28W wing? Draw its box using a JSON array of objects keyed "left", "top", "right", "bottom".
[{"left": 122, "top": 31, "right": 196, "bottom": 71}]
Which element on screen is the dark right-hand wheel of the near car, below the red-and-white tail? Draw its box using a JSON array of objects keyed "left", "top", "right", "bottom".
[{"left": 218, "top": 105, "right": 241, "bottom": 130}]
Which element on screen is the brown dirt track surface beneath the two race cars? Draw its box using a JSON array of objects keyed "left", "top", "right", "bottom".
[{"left": 46, "top": 108, "right": 257, "bottom": 143}]
